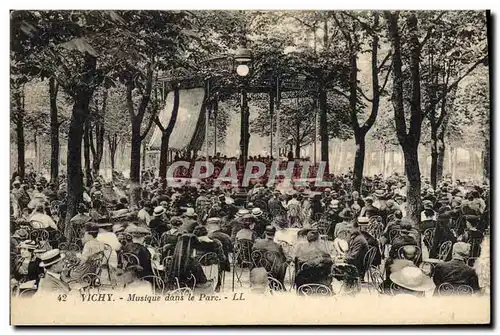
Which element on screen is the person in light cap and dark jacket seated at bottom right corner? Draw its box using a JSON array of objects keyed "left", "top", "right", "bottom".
[{"left": 432, "top": 242, "right": 480, "bottom": 294}]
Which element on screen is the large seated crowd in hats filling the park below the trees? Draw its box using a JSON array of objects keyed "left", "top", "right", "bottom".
[{"left": 10, "top": 168, "right": 490, "bottom": 296}]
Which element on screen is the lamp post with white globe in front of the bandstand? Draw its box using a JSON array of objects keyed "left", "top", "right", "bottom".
[{"left": 234, "top": 48, "right": 253, "bottom": 168}]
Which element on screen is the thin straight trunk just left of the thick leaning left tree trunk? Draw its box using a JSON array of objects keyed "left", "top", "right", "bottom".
[{"left": 49, "top": 78, "right": 59, "bottom": 185}]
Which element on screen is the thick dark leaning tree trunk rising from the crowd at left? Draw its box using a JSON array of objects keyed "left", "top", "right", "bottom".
[{"left": 66, "top": 92, "right": 92, "bottom": 223}]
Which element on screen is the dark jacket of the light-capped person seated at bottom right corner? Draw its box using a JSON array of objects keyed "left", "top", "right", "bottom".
[{"left": 432, "top": 259, "right": 479, "bottom": 292}]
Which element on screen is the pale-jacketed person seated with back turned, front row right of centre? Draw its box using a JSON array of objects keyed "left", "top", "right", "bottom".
[{"left": 295, "top": 228, "right": 333, "bottom": 287}]
